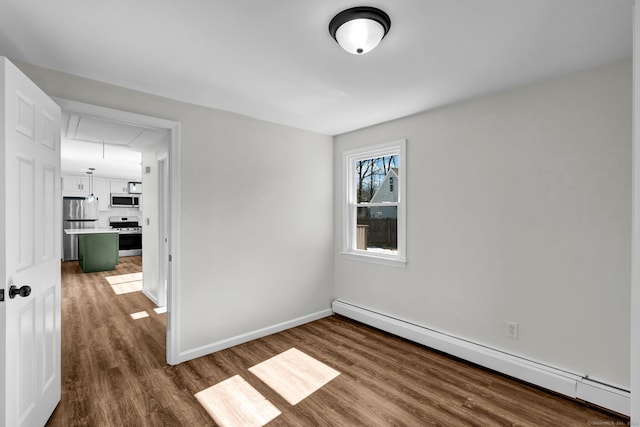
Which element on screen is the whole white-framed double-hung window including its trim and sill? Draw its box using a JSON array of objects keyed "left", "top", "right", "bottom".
[{"left": 342, "top": 139, "right": 406, "bottom": 266}]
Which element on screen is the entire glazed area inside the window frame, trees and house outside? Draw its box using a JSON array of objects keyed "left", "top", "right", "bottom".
[{"left": 354, "top": 154, "right": 399, "bottom": 254}]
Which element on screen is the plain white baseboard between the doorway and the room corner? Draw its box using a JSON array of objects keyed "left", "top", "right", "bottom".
[{"left": 177, "top": 309, "right": 333, "bottom": 363}]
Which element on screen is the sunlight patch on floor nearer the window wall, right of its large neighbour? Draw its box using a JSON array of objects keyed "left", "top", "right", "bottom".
[{"left": 249, "top": 348, "right": 340, "bottom": 405}]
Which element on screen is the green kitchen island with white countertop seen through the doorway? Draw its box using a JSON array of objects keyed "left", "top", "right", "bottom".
[{"left": 64, "top": 228, "right": 119, "bottom": 273}]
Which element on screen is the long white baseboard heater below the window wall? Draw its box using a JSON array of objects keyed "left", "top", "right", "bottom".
[{"left": 331, "top": 300, "right": 631, "bottom": 416}]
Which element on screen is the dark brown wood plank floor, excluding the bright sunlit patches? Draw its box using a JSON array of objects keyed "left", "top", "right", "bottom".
[{"left": 47, "top": 257, "right": 628, "bottom": 427}]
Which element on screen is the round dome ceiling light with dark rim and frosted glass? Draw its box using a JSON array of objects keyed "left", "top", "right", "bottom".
[{"left": 329, "top": 6, "right": 391, "bottom": 55}]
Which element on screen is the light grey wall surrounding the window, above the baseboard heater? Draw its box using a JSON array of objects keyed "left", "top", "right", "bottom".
[{"left": 334, "top": 60, "right": 632, "bottom": 389}]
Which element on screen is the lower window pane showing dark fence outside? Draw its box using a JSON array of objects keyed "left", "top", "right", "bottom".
[{"left": 356, "top": 206, "right": 398, "bottom": 253}]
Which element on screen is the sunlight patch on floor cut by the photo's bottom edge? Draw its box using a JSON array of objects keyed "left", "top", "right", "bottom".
[{"left": 195, "top": 375, "right": 280, "bottom": 427}]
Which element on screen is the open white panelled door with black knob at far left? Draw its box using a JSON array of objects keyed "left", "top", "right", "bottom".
[{"left": 0, "top": 57, "right": 62, "bottom": 427}]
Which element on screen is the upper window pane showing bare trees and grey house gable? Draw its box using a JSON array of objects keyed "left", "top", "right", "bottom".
[{"left": 355, "top": 155, "right": 398, "bottom": 203}]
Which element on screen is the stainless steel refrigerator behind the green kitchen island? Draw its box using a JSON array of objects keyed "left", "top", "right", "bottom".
[{"left": 62, "top": 196, "right": 98, "bottom": 261}]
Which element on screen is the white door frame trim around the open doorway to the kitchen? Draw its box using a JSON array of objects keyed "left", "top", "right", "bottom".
[{"left": 52, "top": 97, "right": 181, "bottom": 365}]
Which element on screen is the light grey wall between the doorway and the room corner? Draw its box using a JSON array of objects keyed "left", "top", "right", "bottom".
[{"left": 17, "top": 63, "right": 333, "bottom": 353}]
